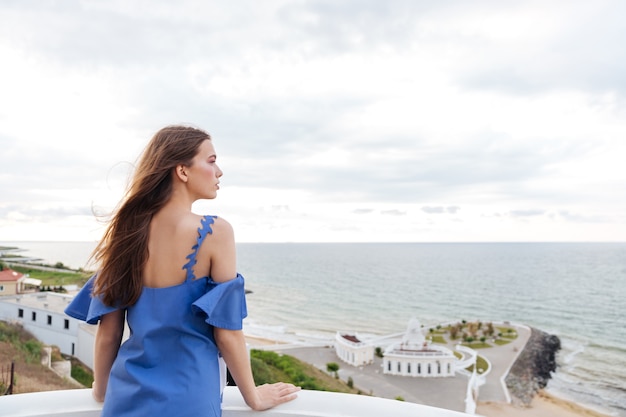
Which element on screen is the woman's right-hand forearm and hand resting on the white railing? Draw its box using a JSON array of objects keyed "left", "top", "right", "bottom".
[{"left": 214, "top": 327, "right": 300, "bottom": 411}]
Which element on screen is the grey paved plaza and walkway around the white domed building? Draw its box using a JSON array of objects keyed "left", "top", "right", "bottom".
[{"left": 246, "top": 323, "right": 530, "bottom": 412}]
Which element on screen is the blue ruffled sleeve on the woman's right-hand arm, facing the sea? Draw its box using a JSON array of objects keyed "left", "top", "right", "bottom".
[{"left": 191, "top": 274, "right": 248, "bottom": 330}]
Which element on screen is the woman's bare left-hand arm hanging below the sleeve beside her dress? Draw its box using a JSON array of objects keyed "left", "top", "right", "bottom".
[{"left": 92, "top": 310, "right": 124, "bottom": 402}]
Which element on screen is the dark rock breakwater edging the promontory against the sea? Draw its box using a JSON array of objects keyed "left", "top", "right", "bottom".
[{"left": 505, "top": 328, "right": 561, "bottom": 406}]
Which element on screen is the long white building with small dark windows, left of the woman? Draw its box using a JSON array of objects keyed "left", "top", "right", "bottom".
[{"left": 0, "top": 292, "right": 97, "bottom": 368}]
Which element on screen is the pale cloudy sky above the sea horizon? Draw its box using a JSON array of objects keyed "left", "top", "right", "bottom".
[{"left": 0, "top": 0, "right": 626, "bottom": 242}]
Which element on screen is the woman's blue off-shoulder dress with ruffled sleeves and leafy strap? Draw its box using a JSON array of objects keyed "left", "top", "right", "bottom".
[{"left": 65, "top": 216, "right": 247, "bottom": 417}]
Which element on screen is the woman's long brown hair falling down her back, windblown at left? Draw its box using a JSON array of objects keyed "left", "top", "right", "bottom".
[{"left": 93, "top": 126, "right": 211, "bottom": 307}]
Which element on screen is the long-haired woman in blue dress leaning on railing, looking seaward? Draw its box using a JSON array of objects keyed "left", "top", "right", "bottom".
[{"left": 66, "top": 126, "right": 299, "bottom": 417}]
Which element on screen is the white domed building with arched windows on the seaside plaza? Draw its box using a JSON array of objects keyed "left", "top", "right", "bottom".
[{"left": 383, "top": 319, "right": 457, "bottom": 377}]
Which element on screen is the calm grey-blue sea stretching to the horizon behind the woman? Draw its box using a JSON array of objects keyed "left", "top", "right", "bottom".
[{"left": 0, "top": 242, "right": 626, "bottom": 417}]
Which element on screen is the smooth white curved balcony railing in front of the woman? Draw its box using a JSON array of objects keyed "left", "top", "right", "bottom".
[{"left": 0, "top": 387, "right": 468, "bottom": 417}]
